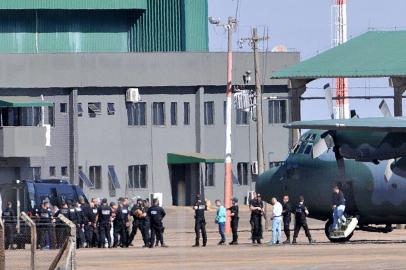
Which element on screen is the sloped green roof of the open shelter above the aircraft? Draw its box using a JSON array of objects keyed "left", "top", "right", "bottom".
[{"left": 272, "top": 31, "right": 406, "bottom": 79}]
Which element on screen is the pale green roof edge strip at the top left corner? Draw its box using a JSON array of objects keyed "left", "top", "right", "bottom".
[{"left": 0, "top": 0, "right": 147, "bottom": 10}]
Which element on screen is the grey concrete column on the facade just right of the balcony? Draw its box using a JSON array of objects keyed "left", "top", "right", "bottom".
[{"left": 69, "top": 89, "right": 79, "bottom": 184}]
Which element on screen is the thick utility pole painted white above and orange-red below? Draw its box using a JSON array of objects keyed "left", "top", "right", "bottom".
[{"left": 209, "top": 17, "right": 237, "bottom": 233}]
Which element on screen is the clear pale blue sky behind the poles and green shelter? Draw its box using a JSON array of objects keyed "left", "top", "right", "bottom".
[{"left": 209, "top": 0, "right": 406, "bottom": 120}]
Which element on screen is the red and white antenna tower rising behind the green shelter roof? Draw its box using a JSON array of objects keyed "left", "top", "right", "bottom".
[{"left": 332, "top": 0, "right": 350, "bottom": 119}]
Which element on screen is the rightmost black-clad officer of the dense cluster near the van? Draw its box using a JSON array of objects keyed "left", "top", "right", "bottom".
[{"left": 147, "top": 199, "right": 168, "bottom": 248}]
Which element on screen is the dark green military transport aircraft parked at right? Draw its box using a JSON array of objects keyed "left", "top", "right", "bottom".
[{"left": 256, "top": 102, "right": 406, "bottom": 242}]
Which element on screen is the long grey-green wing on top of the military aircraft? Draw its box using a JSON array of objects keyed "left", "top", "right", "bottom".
[{"left": 284, "top": 117, "right": 406, "bottom": 133}]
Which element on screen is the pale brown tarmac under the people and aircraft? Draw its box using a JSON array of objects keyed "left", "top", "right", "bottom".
[{"left": 6, "top": 205, "right": 406, "bottom": 270}]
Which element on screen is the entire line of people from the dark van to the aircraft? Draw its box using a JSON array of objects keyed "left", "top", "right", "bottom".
[{"left": 2, "top": 190, "right": 345, "bottom": 249}]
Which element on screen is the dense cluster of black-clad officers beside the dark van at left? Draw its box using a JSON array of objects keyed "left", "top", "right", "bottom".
[{"left": 2, "top": 197, "right": 167, "bottom": 249}]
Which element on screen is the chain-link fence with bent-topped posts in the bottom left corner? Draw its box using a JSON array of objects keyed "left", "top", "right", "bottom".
[{"left": 0, "top": 213, "right": 76, "bottom": 270}]
